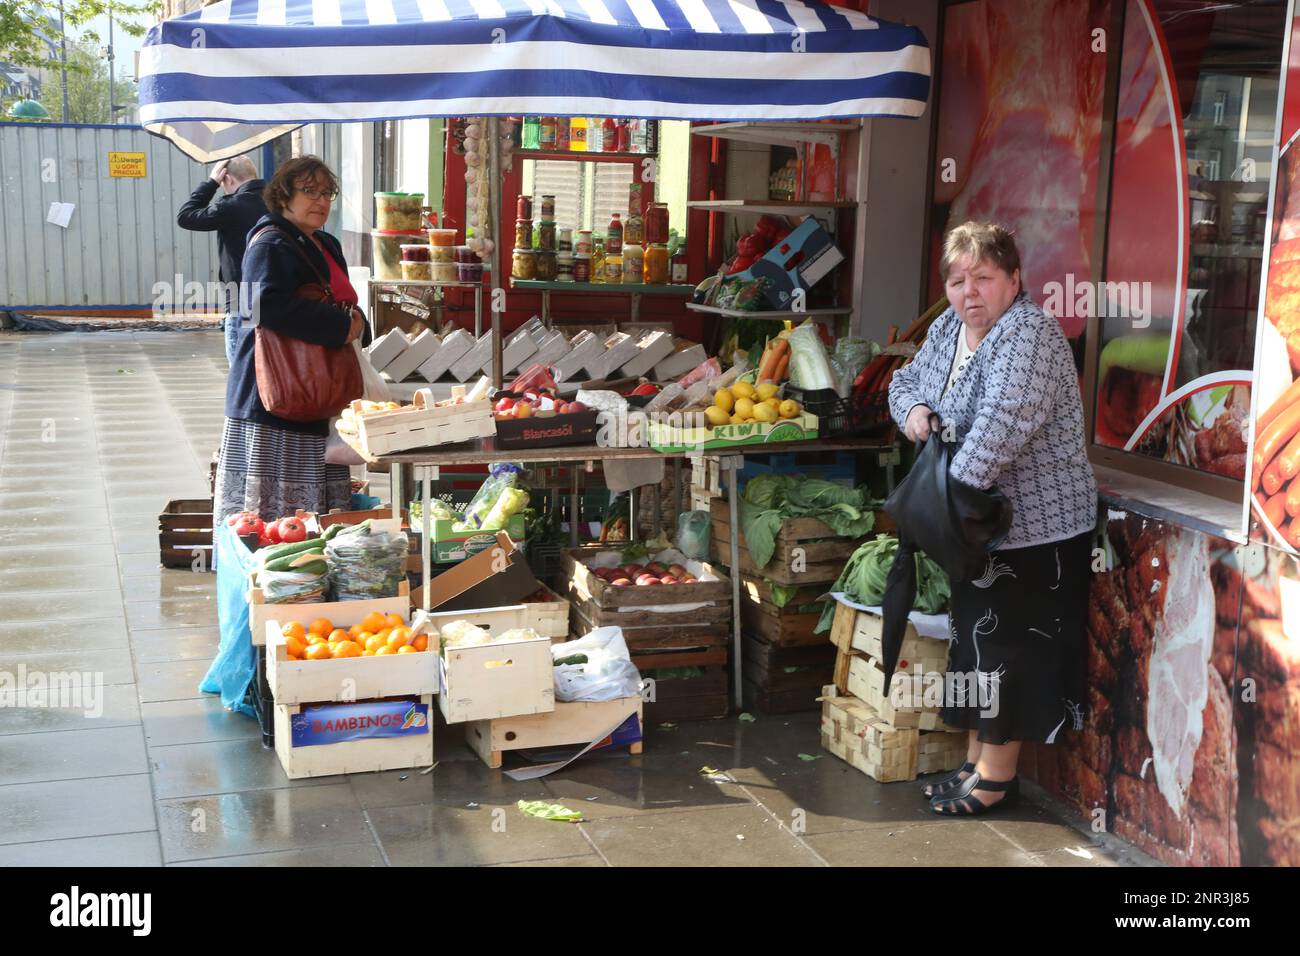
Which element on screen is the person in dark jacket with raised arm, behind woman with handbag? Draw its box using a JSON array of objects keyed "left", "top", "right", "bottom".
[{"left": 176, "top": 156, "right": 267, "bottom": 363}]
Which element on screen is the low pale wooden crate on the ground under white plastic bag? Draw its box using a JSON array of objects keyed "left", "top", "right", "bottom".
[{"left": 465, "top": 697, "right": 642, "bottom": 770}]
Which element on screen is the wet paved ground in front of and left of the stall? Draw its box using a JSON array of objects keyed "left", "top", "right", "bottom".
[{"left": 0, "top": 332, "right": 1145, "bottom": 866}]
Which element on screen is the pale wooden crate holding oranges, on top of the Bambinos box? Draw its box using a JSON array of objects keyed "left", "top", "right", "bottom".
[{"left": 265, "top": 616, "right": 439, "bottom": 704}]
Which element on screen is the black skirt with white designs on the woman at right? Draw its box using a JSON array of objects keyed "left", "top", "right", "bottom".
[{"left": 941, "top": 531, "right": 1093, "bottom": 744}]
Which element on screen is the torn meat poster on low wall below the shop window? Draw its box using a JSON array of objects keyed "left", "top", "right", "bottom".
[{"left": 1022, "top": 511, "right": 1300, "bottom": 866}]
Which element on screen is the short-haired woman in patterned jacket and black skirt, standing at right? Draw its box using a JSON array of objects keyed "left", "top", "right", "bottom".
[{"left": 889, "top": 222, "right": 1097, "bottom": 814}]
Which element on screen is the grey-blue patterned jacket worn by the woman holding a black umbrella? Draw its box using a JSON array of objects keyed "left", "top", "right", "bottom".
[{"left": 889, "top": 293, "right": 1097, "bottom": 548}]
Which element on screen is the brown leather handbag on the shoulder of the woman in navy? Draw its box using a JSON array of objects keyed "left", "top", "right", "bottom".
[{"left": 248, "top": 226, "right": 365, "bottom": 421}]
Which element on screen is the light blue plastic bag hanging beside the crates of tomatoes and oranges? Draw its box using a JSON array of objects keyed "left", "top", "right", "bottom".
[{"left": 199, "top": 522, "right": 257, "bottom": 718}]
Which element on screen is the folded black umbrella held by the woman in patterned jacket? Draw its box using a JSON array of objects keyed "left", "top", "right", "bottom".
[{"left": 880, "top": 415, "right": 1011, "bottom": 688}]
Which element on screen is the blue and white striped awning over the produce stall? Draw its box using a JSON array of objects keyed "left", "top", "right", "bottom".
[{"left": 139, "top": 0, "right": 930, "bottom": 159}]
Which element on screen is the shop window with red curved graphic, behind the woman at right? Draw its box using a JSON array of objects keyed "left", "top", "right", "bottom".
[{"left": 1093, "top": 0, "right": 1284, "bottom": 486}]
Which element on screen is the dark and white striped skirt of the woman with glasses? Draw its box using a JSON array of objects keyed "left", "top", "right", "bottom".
[{"left": 215, "top": 419, "right": 351, "bottom": 522}]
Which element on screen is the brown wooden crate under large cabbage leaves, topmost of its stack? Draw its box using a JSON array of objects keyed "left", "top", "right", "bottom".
[{"left": 709, "top": 498, "right": 866, "bottom": 585}]
